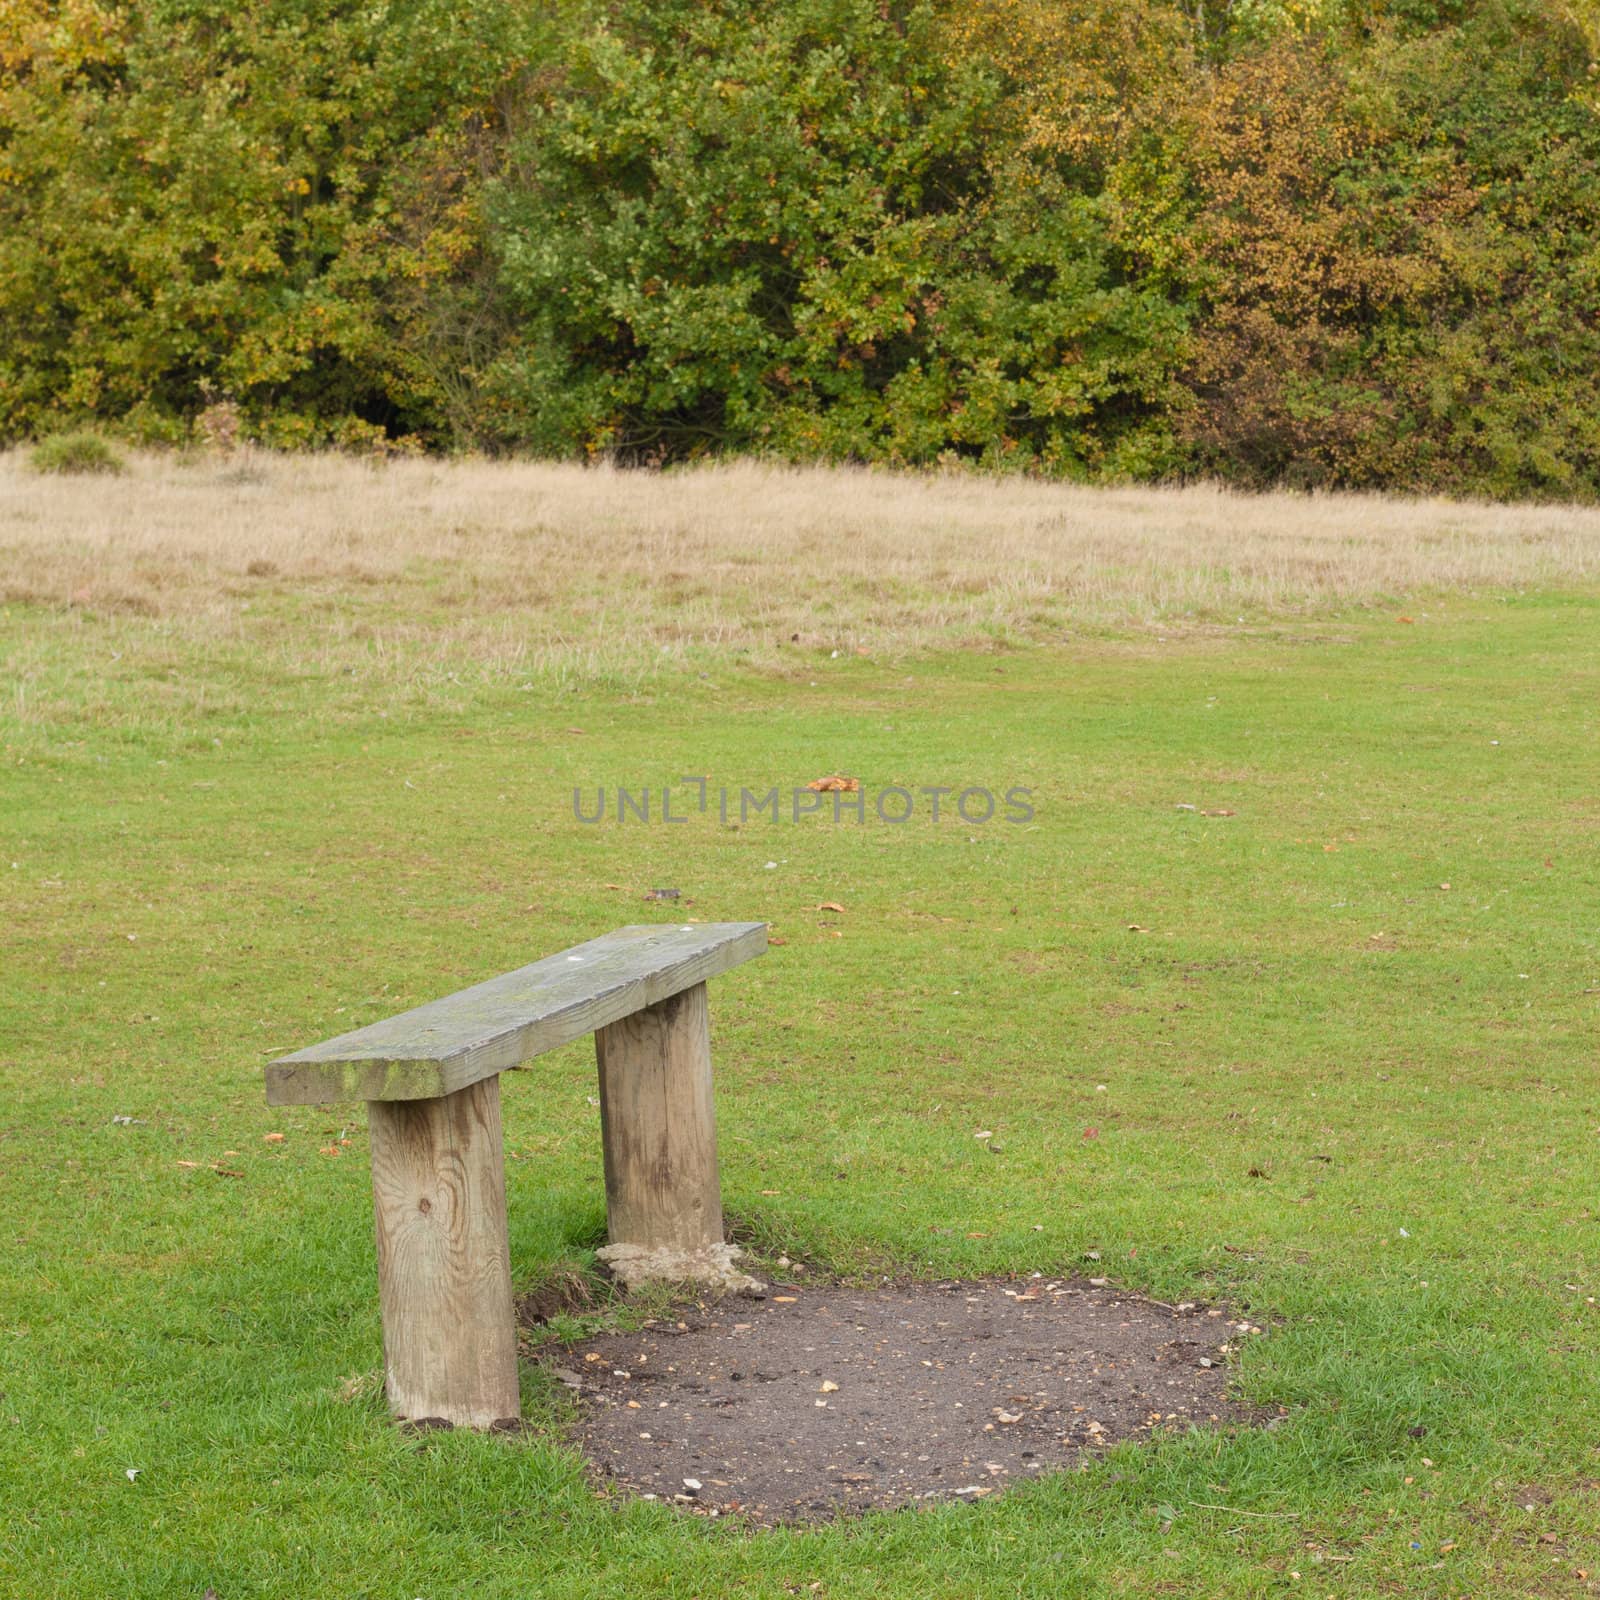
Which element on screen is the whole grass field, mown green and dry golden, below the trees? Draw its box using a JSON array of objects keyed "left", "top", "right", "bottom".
[{"left": 9, "top": 458, "right": 1600, "bottom": 1600}]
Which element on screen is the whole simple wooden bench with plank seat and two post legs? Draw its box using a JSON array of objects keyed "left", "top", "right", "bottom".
[{"left": 267, "top": 922, "right": 766, "bottom": 1427}]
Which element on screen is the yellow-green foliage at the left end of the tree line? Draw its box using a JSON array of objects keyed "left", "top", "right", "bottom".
[{"left": 0, "top": 0, "right": 553, "bottom": 442}]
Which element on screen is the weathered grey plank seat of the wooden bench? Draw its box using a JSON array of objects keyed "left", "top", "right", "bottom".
[{"left": 267, "top": 922, "right": 766, "bottom": 1106}]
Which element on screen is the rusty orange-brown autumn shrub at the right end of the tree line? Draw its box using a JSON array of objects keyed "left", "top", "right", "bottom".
[{"left": 1165, "top": 5, "right": 1600, "bottom": 499}]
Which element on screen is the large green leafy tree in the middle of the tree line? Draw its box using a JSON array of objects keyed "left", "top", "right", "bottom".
[{"left": 480, "top": 0, "right": 1181, "bottom": 470}]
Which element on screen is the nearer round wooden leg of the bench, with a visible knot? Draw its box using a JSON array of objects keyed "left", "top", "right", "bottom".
[{"left": 366, "top": 1078, "right": 520, "bottom": 1427}]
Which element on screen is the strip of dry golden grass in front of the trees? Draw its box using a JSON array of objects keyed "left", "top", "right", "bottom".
[{"left": 0, "top": 453, "right": 1600, "bottom": 694}]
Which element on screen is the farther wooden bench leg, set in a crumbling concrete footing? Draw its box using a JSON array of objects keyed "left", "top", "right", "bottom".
[{"left": 595, "top": 984, "right": 722, "bottom": 1250}]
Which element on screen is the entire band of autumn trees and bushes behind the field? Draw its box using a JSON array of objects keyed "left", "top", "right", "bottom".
[{"left": 0, "top": 0, "right": 1600, "bottom": 498}]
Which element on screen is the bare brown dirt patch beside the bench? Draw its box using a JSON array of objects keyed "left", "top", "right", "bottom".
[{"left": 547, "top": 1278, "right": 1253, "bottom": 1522}]
